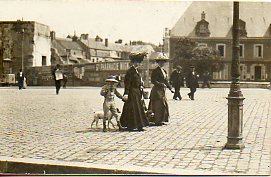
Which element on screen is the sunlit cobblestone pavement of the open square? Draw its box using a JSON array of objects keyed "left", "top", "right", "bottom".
[{"left": 0, "top": 87, "right": 271, "bottom": 175}]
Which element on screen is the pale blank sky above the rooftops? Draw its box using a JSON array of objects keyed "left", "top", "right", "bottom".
[{"left": 0, "top": 0, "right": 191, "bottom": 45}]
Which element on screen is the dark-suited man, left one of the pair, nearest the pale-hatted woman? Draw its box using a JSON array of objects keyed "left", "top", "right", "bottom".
[{"left": 170, "top": 66, "right": 184, "bottom": 100}]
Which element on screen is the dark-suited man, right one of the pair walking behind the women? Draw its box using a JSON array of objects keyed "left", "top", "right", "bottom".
[{"left": 186, "top": 66, "right": 199, "bottom": 100}]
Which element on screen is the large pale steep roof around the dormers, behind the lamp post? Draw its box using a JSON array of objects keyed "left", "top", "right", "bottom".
[{"left": 171, "top": 1, "right": 271, "bottom": 38}]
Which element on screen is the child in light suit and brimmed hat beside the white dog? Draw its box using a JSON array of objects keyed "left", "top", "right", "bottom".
[{"left": 100, "top": 76, "right": 123, "bottom": 132}]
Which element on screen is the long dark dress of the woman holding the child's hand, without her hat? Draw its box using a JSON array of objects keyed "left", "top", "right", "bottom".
[{"left": 120, "top": 67, "right": 149, "bottom": 129}]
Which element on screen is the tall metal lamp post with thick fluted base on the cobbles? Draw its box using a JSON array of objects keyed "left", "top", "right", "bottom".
[{"left": 224, "top": 2, "right": 245, "bottom": 149}]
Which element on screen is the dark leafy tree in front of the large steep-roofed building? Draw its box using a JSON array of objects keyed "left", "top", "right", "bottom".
[{"left": 173, "top": 38, "right": 224, "bottom": 74}]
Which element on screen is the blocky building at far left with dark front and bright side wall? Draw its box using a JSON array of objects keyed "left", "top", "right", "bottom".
[{"left": 0, "top": 20, "right": 51, "bottom": 74}]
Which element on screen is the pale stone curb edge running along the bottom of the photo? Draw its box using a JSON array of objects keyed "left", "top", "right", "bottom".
[{"left": 0, "top": 156, "right": 236, "bottom": 175}]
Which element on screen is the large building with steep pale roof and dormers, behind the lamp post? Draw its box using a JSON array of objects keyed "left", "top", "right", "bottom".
[{"left": 169, "top": 1, "right": 271, "bottom": 81}]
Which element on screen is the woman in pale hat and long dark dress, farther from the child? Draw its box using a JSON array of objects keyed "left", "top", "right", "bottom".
[{"left": 148, "top": 55, "right": 174, "bottom": 126}]
